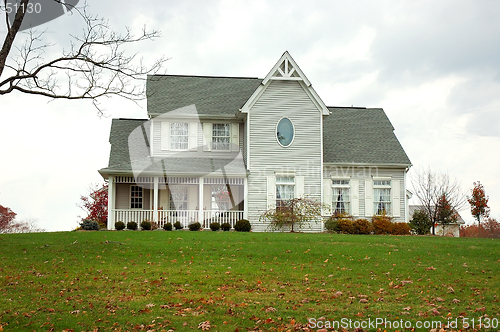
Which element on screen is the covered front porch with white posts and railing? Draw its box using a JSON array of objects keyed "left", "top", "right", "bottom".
[{"left": 108, "top": 175, "right": 247, "bottom": 229}]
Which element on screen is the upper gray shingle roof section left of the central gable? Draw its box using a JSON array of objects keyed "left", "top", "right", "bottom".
[{"left": 146, "top": 75, "right": 262, "bottom": 115}]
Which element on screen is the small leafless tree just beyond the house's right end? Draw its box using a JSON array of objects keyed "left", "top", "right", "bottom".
[{"left": 411, "top": 169, "right": 467, "bottom": 234}]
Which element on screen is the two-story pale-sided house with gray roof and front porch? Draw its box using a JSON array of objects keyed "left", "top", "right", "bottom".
[{"left": 99, "top": 52, "right": 411, "bottom": 231}]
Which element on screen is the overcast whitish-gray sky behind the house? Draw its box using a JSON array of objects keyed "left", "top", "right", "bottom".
[{"left": 0, "top": 0, "right": 500, "bottom": 231}]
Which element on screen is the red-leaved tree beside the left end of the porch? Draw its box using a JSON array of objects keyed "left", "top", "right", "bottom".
[{"left": 80, "top": 183, "right": 108, "bottom": 228}]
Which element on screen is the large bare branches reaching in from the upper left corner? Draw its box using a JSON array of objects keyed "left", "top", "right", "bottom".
[{"left": 0, "top": 0, "right": 166, "bottom": 113}]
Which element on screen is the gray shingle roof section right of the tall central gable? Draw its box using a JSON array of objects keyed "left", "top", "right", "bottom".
[{"left": 323, "top": 107, "right": 411, "bottom": 166}]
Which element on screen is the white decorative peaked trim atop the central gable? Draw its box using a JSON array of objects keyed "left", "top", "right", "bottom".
[{"left": 240, "top": 51, "right": 330, "bottom": 115}]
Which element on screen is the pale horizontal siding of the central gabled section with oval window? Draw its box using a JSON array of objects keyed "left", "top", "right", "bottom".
[{"left": 248, "top": 81, "right": 322, "bottom": 231}]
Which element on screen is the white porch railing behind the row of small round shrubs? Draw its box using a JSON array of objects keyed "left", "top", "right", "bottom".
[{"left": 114, "top": 209, "right": 243, "bottom": 229}]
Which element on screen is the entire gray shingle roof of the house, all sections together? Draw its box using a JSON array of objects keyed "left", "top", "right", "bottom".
[{"left": 101, "top": 76, "right": 411, "bottom": 178}]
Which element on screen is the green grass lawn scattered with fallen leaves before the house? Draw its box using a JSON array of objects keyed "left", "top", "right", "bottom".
[{"left": 0, "top": 231, "right": 500, "bottom": 331}]
